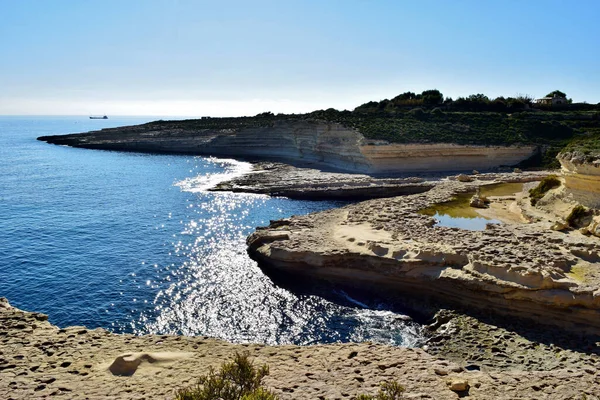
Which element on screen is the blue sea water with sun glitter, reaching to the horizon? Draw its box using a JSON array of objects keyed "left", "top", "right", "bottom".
[{"left": 0, "top": 117, "right": 419, "bottom": 346}]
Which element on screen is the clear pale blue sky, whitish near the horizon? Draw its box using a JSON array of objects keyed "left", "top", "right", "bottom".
[{"left": 0, "top": 0, "right": 600, "bottom": 116}]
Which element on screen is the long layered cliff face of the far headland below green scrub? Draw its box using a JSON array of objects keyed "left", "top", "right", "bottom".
[{"left": 39, "top": 120, "right": 535, "bottom": 174}]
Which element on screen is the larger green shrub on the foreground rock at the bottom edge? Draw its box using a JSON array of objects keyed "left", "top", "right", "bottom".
[{"left": 176, "top": 352, "right": 279, "bottom": 400}]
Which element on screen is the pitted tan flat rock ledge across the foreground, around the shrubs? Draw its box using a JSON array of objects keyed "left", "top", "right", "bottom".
[{"left": 0, "top": 298, "right": 600, "bottom": 400}]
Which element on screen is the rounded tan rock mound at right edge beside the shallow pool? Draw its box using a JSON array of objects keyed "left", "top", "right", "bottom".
[{"left": 557, "top": 152, "right": 600, "bottom": 208}]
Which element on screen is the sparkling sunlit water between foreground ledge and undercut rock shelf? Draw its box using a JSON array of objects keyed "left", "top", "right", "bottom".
[{"left": 132, "top": 186, "right": 421, "bottom": 346}]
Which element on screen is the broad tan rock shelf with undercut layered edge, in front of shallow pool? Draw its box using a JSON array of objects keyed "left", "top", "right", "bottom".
[{"left": 247, "top": 181, "right": 600, "bottom": 333}]
